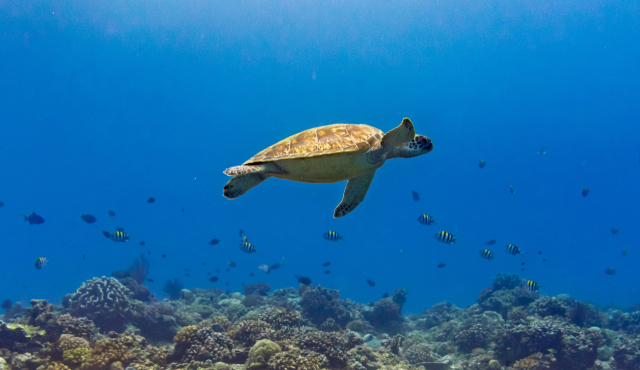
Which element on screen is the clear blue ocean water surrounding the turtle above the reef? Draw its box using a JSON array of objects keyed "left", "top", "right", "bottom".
[{"left": 0, "top": 0, "right": 640, "bottom": 313}]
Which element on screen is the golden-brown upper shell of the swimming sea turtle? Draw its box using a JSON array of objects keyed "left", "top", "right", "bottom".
[{"left": 244, "top": 123, "right": 384, "bottom": 164}]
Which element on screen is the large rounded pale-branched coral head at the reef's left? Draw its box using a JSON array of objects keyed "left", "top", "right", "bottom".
[{"left": 69, "top": 276, "right": 132, "bottom": 332}]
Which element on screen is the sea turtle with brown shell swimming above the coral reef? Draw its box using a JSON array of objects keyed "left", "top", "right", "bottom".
[{"left": 222, "top": 118, "right": 433, "bottom": 218}]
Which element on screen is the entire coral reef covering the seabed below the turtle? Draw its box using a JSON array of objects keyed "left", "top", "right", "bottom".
[{"left": 0, "top": 272, "right": 640, "bottom": 370}]
